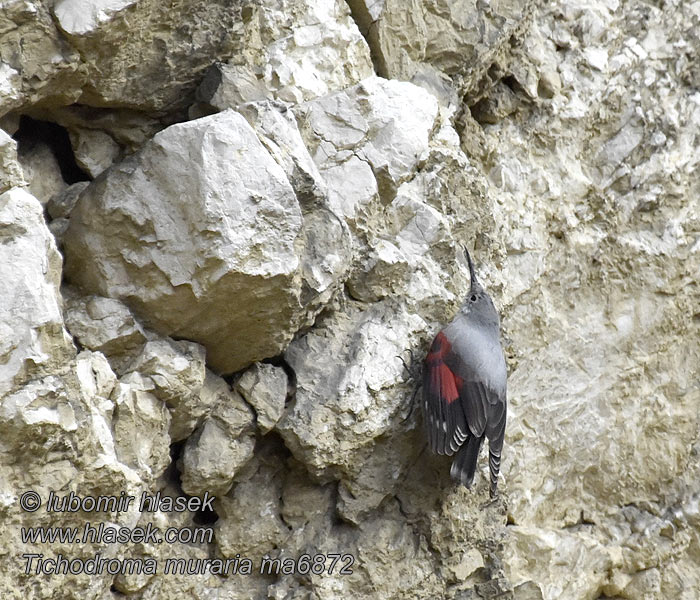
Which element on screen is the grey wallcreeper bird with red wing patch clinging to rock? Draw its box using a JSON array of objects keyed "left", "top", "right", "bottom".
[{"left": 423, "top": 248, "right": 507, "bottom": 497}]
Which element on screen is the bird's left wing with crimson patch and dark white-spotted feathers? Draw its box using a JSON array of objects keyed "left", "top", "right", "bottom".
[{"left": 423, "top": 333, "right": 470, "bottom": 456}]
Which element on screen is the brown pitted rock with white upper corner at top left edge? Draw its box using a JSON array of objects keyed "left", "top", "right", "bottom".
[{"left": 52, "top": 0, "right": 241, "bottom": 112}]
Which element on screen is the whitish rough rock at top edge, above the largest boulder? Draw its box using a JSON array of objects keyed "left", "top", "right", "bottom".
[{"left": 197, "top": 0, "right": 372, "bottom": 110}]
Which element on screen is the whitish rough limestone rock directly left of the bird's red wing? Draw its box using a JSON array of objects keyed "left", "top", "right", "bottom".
[{"left": 277, "top": 303, "right": 425, "bottom": 477}]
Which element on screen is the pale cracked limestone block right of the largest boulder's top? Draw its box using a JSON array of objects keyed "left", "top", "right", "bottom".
[{"left": 295, "top": 77, "right": 438, "bottom": 213}]
